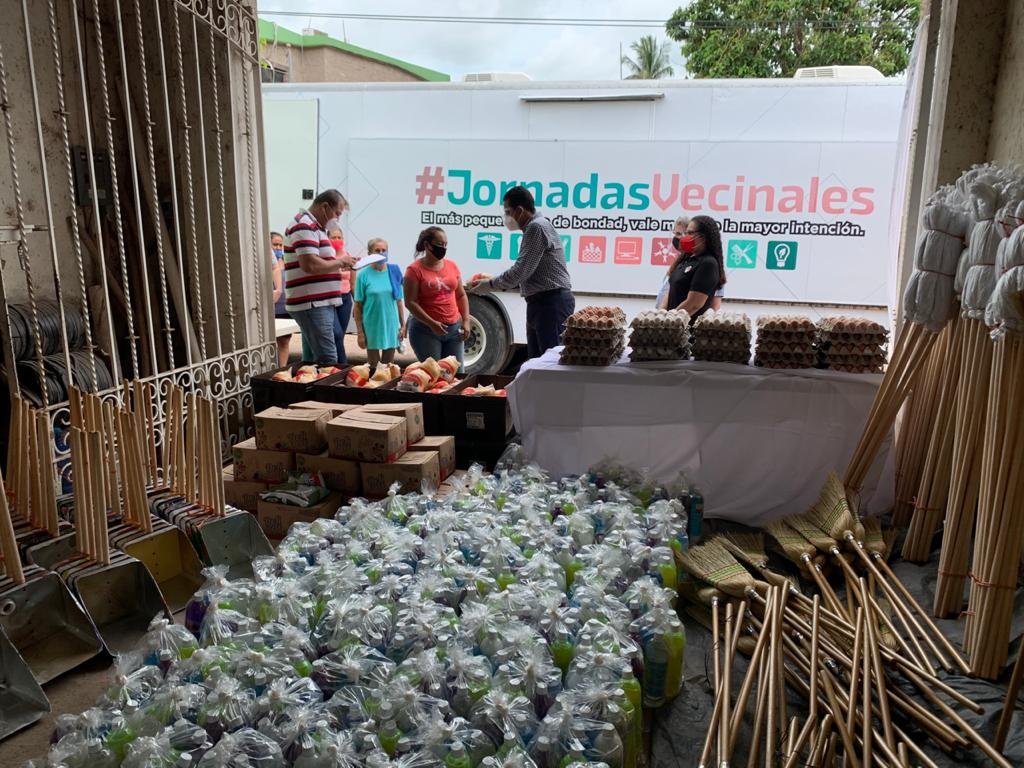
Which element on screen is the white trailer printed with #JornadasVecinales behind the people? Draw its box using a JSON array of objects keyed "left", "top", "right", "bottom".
[{"left": 263, "top": 79, "right": 905, "bottom": 372}]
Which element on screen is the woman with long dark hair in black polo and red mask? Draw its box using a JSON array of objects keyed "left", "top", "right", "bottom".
[{"left": 668, "top": 216, "right": 725, "bottom": 321}]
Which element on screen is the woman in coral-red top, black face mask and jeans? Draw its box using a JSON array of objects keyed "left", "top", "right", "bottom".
[{"left": 404, "top": 226, "right": 469, "bottom": 368}]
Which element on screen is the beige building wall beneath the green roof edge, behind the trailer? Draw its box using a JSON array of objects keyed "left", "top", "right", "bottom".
[{"left": 260, "top": 45, "right": 421, "bottom": 83}]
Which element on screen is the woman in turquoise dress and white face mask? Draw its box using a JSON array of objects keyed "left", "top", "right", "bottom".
[{"left": 353, "top": 238, "right": 406, "bottom": 370}]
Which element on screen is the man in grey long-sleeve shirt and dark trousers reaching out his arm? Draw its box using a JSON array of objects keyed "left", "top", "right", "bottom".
[{"left": 467, "top": 186, "right": 575, "bottom": 357}]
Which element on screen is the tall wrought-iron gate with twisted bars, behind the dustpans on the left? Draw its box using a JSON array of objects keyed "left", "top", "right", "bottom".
[{"left": 0, "top": 0, "right": 275, "bottom": 487}]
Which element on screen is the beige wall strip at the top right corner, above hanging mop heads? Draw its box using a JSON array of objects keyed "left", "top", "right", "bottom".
[{"left": 988, "top": 0, "right": 1024, "bottom": 165}]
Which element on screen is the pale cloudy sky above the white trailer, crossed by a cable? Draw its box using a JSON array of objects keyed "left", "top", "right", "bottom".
[{"left": 259, "top": 0, "right": 684, "bottom": 80}]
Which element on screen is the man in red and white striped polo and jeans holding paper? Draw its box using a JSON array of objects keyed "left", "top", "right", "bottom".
[{"left": 285, "top": 189, "right": 355, "bottom": 366}]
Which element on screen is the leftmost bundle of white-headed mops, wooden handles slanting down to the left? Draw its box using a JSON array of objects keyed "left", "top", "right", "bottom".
[{"left": 846, "top": 187, "right": 970, "bottom": 497}]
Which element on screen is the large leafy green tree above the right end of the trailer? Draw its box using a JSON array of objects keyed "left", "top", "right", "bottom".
[{"left": 666, "top": 0, "right": 919, "bottom": 78}]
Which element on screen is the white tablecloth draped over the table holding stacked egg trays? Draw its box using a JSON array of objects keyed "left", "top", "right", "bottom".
[{"left": 509, "top": 349, "right": 895, "bottom": 525}]
